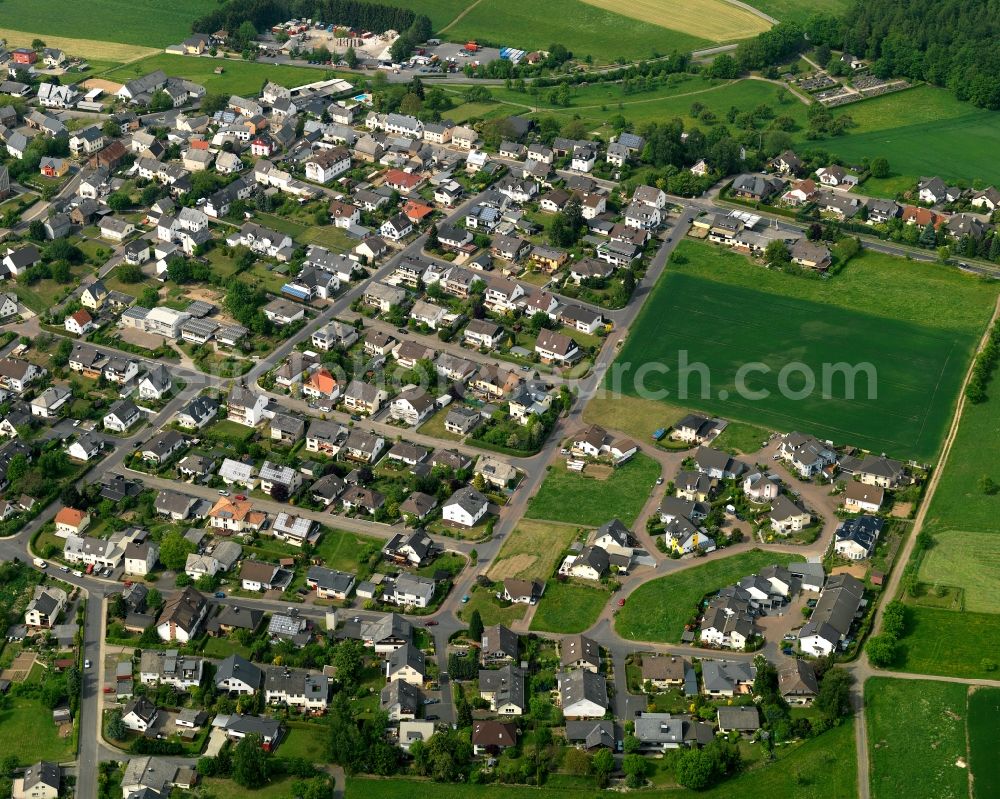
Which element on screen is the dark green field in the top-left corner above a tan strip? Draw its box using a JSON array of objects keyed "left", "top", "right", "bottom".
[{"left": 0, "top": 0, "right": 205, "bottom": 47}]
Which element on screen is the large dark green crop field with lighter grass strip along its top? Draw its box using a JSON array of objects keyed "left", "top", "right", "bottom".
[{"left": 609, "top": 241, "right": 996, "bottom": 461}]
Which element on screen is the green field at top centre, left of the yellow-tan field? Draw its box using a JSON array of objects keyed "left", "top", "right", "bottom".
[{"left": 447, "top": 0, "right": 710, "bottom": 63}]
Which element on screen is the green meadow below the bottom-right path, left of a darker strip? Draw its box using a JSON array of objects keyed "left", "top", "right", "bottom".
[{"left": 865, "top": 677, "right": 969, "bottom": 799}]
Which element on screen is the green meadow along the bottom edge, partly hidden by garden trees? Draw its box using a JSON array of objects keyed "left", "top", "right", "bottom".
[{"left": 346, "top": 720, "right": 858, "bottom": 799}]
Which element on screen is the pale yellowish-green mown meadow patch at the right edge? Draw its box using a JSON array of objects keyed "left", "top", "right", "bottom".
[{"left": 919, "top": 530, "right": 1000, "bottom": 613}]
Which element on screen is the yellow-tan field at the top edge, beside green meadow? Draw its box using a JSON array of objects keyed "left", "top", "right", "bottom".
[{"left": 583, "top": 0, "right": 771, "bottom": 42}]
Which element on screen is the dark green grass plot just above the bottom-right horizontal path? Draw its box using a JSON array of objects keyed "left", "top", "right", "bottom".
[{"left": 894, "top": 605, "right": 1000, "bottom": 680}]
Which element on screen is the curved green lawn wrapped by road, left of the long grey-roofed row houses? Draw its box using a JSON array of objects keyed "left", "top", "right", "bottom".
[{"left": 615, "top": 549, "right": 803, "bottom": 643}]
